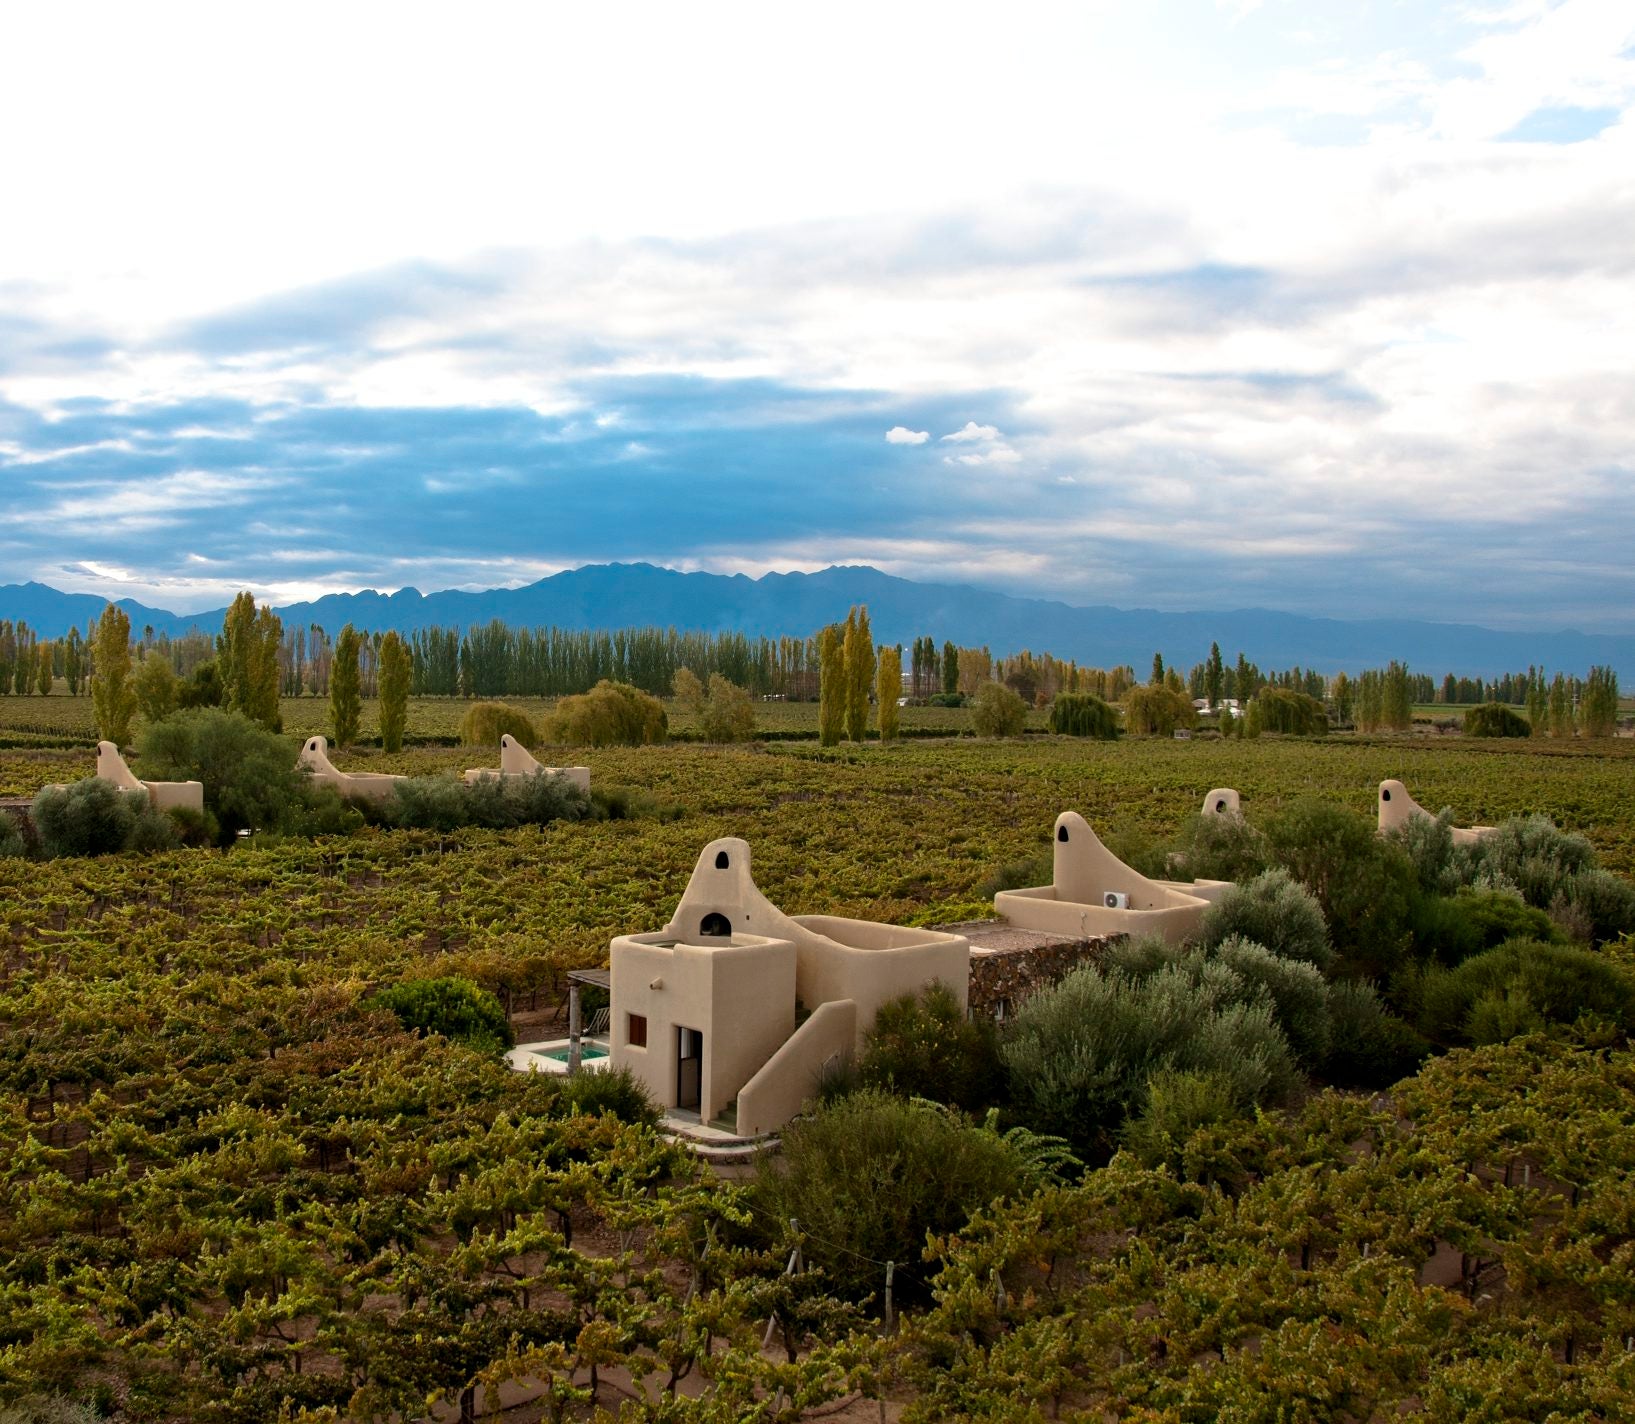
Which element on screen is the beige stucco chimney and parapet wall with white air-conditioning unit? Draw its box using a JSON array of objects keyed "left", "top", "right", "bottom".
[{"left": 994, "top": 811, "right": 1226, "bottom": 943}]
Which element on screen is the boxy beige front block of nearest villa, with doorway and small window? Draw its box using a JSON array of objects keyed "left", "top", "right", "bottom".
[{"left": 608, "top": 932, "right": 795, "bottom": 1122}]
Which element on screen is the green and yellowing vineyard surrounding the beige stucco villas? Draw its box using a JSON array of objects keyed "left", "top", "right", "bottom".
[{"left": 0, "top": 698, "right": 1635, "bottom": 1421}]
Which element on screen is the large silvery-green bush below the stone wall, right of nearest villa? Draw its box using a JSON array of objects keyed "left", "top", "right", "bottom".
[{"left": 1001, "top": 963, "right": 1298, "bottom": 1153}]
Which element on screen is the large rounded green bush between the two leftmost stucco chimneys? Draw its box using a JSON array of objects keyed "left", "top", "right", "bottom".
[{"left": 137, "top": 708, "right": 304, "bottom": 844}]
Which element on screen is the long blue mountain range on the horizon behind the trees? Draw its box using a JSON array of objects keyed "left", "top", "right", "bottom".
[{"left": 0, "top": 564, "right": 1635, "bottom": 682}]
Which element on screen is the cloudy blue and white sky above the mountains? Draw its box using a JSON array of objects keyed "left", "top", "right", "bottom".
[{"left": 0, "top": 0, "right": 1635, "bottom": 631}]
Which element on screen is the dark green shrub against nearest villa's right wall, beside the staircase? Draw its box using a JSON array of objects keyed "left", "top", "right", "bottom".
[{"left": 857, "top": 981, "right": 1004, "bottom": 1112}]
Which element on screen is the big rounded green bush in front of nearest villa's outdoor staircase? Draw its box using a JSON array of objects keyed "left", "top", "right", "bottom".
[{"left": 755, "top": 1089, "right": 1020, "bottom": 1300}]
